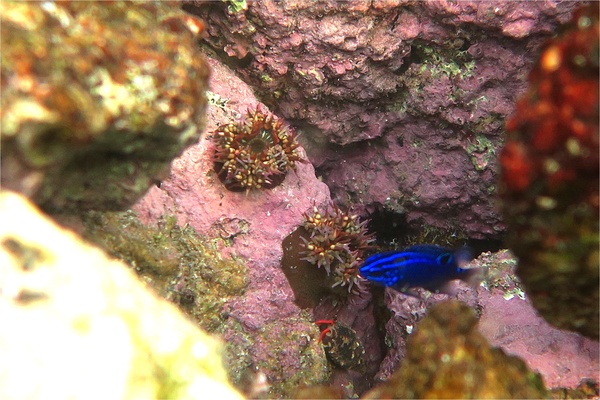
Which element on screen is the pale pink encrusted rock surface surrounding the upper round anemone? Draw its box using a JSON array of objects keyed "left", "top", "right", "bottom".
[{"left": 134, "top": 59, "right": 329, "bottom": 397}]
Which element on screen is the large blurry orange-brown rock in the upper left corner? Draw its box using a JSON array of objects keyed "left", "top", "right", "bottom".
[{"left": 0, "top": 1, "right": 208, "bottom": 213}]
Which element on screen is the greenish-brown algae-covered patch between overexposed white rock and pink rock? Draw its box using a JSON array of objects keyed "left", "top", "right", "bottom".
[{"left": 84, "top": 211, "right": 246, "bottom": 332}]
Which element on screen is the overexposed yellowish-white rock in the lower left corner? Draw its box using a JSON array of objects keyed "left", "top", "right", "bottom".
[{"left": 0, "top": 190, "right": 243, "bottom": 399}]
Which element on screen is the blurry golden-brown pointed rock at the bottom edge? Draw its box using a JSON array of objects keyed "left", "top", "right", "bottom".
[{"left": 364, "top": 301, "right": 547, "bottom": 399}]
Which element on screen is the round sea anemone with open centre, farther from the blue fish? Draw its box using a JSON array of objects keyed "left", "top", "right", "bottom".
[{"left": 212, "top": 106, "right": 304, "bottom": 192}]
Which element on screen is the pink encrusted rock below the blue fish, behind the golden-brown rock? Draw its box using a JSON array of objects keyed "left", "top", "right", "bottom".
[{"left": 375, "top": 250, "right": 600, "bottom": 389}]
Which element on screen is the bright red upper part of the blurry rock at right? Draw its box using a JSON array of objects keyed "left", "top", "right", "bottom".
[{"left": 500, "top": 4, "right": 599, "bottom": 194}]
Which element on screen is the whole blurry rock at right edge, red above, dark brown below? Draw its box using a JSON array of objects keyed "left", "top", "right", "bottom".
[{"left": 500, "top": 3, "right": 599, "bottom": 338}]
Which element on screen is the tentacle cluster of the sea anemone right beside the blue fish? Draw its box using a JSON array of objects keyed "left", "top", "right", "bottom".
[{"left": 302, "top": 204, "right": 374, "bottom": 292}]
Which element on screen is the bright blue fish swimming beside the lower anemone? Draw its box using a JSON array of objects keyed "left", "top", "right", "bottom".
[{"left": 360, "top": 244, "right": 481, "bottom": 295}]
